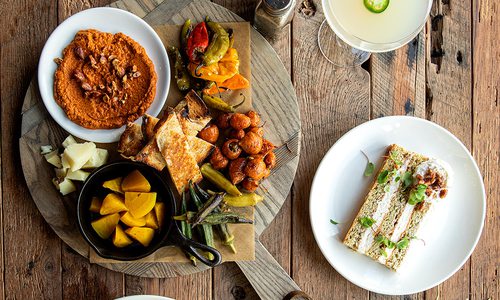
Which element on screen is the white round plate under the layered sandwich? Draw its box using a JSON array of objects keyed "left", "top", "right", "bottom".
[{"left": 309, "top": 116, "right": 486, "bottom": 295}]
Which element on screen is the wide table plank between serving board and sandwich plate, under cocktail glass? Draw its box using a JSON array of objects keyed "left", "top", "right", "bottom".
[{"left": 291, "top": 1, "right": 370, "bottom": 299}]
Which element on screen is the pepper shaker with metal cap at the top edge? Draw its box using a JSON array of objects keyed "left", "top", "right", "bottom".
[{"left": 253, "top": 0, "right": 296, "bottom": 40}]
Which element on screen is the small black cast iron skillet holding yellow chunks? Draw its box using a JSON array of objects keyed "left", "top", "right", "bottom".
[{"left": 77, "top": 161, "right": 221, "bottom": 267}]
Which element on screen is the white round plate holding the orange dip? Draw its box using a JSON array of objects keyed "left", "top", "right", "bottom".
[{"left": 38, "top": 7, "right": 170, "bottom": 143}]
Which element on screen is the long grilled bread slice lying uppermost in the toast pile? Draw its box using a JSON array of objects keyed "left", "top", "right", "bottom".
[{"left": 155, "top": 112, "right": 202, "bottom": 194}]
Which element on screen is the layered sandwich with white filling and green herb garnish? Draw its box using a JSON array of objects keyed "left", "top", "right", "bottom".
[{"left": 344, "top": 144, "right": 449, "bottom": 270}]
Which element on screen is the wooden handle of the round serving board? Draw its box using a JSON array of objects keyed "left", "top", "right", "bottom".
[{"left": 236, "top": 240, "right": 311, "bottom": 300}]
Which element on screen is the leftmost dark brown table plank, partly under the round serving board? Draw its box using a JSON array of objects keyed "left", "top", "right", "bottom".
[{"left": 0, "top": 1, "right": 61, "bottom": 299}]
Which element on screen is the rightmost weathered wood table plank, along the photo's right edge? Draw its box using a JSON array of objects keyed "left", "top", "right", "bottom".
[{"left": 470, "top": 0, "right": 500, "bottom": 299}]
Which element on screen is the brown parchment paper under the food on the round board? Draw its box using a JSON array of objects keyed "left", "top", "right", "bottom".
[{"left": 89, "top": 22, "right": 255, "bottom": 263}]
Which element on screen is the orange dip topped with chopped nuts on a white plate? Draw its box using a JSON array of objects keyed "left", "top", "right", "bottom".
[{"left": 54, "top": 29, "right": 157, "bottom": 129}]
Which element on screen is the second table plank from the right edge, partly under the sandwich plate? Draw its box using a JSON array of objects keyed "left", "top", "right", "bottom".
[{"left": 426, "top": 0, "right": 472, "bottom": 299}]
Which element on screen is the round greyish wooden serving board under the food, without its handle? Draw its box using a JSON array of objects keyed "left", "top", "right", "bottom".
[{"left": 19, "top": 0, "right": 300, "bottom": 277}]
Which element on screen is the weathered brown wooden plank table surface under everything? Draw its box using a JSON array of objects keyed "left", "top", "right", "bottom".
[{"left": 0, "top": 0, "right": 500, "bottom": 300}]
